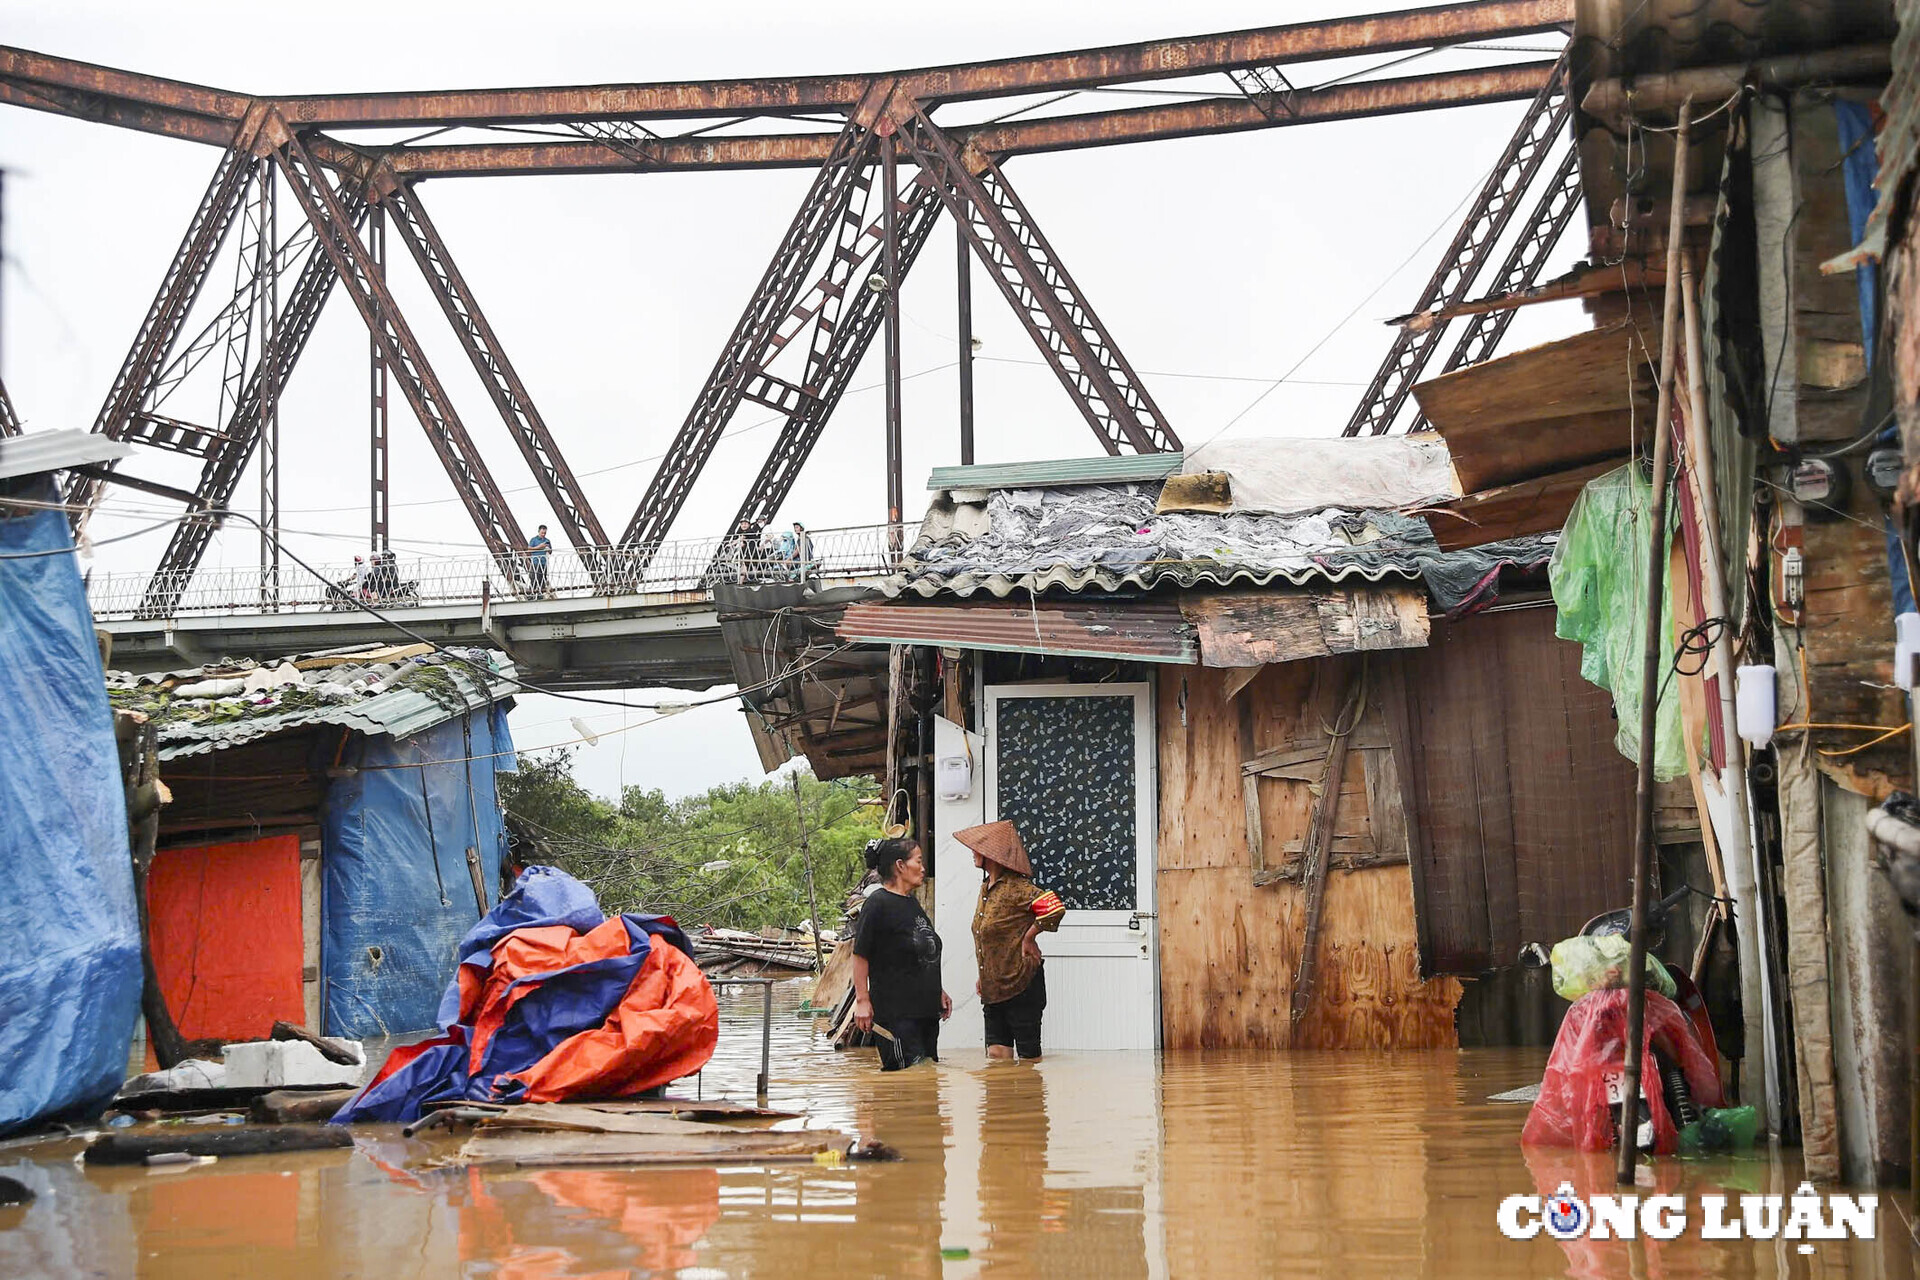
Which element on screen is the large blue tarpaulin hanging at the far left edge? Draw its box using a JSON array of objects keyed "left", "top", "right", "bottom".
[{"left": 0, "top": 484, "right": 142, "bottom": 1134}]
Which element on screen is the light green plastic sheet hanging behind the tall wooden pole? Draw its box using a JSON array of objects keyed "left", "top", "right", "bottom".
[{"left": 1548, "top": 464, "right": 1686, "bottom": 783}]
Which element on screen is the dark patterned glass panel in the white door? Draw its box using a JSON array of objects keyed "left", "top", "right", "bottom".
[{"left": 996, "top": 697, "right": 1139, "bottom": 912}]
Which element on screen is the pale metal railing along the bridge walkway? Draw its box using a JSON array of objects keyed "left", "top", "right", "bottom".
[{"left": 86, "top": 524, "right": 918, "bottom": 620}]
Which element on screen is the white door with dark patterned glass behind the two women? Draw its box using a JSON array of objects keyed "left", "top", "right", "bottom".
[{"left": 985, "top": 683, "right": 1160, "bottom": 1050}]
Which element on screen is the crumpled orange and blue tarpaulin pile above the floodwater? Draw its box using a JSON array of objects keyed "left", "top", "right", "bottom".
[{"left": 334, "top": 867, "right": 720, "bottom": 1125}]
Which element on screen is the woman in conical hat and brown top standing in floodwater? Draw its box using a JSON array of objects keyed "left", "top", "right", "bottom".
[{"left": 954, "top": 821, "right": 1068, "bottom": 1057}]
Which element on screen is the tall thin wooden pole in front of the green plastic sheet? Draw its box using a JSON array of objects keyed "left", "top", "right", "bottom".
[{"left": 1615, "top": 96, "right": 1693, "bottom": 1186}]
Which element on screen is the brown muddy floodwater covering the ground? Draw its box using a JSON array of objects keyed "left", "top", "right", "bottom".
[{"left": 0, "top": 983, "right": 1914, "bottom": 1280}]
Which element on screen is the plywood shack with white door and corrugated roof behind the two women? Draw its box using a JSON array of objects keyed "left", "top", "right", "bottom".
[{"left": 839, "top": 438, "right": 1681, "bottom": 1048}]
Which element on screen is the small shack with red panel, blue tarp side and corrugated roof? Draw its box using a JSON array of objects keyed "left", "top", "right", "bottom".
[{"left": 108, "top": 645, "right": 515, "bottom": 1040}]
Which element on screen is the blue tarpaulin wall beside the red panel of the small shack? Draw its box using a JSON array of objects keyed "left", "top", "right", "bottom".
[{"left": 321, "top": 706, "right": 515, "bottom": 1036}]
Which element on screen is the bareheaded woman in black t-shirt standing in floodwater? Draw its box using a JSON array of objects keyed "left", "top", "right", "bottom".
[{"left": 852, "top": 841, "right": 954, "bottom": 1071}]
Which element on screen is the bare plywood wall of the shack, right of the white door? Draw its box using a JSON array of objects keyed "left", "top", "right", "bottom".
[{"left": 1158, "top": 658, "right": 1459, "bottom": 1050}]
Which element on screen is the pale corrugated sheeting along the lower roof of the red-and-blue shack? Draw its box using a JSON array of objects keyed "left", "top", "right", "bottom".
[{"left": 124, "top": 651, "right": 518, "bottom": 760}]
